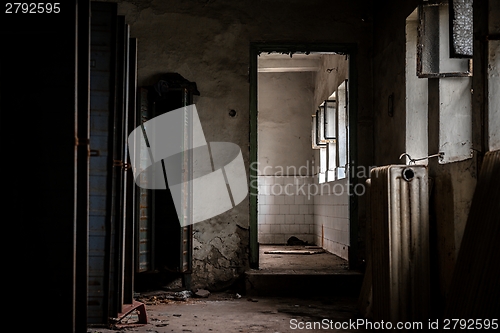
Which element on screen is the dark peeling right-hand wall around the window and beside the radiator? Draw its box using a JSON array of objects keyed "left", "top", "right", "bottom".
[{"left": 373, "top": 1, "right": 480, "bottom": 311}]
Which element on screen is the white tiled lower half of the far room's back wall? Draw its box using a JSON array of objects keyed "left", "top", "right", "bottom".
[{"left": 257, "top": 176, "right": 315, "bottom": 244}]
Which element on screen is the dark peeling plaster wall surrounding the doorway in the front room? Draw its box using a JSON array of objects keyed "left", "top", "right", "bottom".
[{"left": 104, "top": 0, "right": 372, "bottom": 288}]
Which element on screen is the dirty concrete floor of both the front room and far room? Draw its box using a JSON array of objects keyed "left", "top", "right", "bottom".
[{"left": 88, "top": 246, "right": 360, "bottom": 333}]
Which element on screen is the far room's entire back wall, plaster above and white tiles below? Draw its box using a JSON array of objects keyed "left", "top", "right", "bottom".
[{"left": 257, "top": 72, "right": 316, "bottom": 244}]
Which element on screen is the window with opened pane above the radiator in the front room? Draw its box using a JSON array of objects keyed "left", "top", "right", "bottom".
[{"left": 412, "top": 0, "right": 472, "bottom": 164}]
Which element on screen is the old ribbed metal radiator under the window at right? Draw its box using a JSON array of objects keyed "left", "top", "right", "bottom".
[{"left": 369, "top": 165, "right": 430, "bottom": 323}]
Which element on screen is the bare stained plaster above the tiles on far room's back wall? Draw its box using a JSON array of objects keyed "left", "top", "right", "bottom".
[{"left": 257, "top": 72, "right": 315, "bottom": 172}]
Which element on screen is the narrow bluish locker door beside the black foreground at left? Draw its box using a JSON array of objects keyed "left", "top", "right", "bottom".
[{"left": 87, "top": 2, "right": 117, "bottom": 324}]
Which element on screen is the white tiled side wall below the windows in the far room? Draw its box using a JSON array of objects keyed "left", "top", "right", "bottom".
[{"left": 314, "top": 179, "right": 349, "bottom": 259}]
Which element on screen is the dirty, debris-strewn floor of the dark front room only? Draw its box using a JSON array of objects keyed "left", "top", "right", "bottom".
[{"left": 88, "top": 291, "right": 366, "bottom": 333}]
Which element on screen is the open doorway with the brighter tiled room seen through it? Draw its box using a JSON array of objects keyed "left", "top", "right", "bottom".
[{"left": 250, "top": 44, "right": 357, "bottom": 268}]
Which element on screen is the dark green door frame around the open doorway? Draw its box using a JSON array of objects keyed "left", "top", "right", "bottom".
[{"left": 249, "top": 42, "right": 358, "bottom": 269}]
